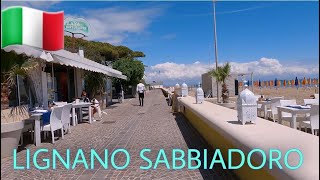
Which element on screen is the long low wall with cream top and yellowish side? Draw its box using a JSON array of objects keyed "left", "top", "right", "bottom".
[{"left": 178, "top": 97, "right": 319, "bottom": 180}]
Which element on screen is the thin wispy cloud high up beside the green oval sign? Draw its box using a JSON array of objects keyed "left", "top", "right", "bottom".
[{"left": 65, "top": 7, "right": 162, "bottom": 44}]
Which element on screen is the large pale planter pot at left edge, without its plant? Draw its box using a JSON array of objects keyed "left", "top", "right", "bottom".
[{"left": 1, "top": 121, "right": 24, "bottom": 159}]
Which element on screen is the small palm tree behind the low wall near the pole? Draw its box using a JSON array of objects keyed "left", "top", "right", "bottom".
[{"left": 209, "top": 62, "right": 231, "bottom": 103}]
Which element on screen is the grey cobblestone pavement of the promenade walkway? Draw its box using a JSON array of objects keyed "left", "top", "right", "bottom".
[{"left": 1, "top": 90, "right": 236, "bottom": 179}]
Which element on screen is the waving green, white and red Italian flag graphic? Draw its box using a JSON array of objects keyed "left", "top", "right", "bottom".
[{"left": 1, "top": 6, "right": 64, "bottom": 51}]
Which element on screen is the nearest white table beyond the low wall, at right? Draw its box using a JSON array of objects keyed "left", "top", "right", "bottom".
[{"left": 277, "top": 105, "right": 311, "bottom": 129}]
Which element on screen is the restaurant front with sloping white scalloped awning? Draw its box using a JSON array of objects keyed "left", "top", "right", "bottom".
[{"left": 3, "top": 45, "right": 127, "bottom": 107}]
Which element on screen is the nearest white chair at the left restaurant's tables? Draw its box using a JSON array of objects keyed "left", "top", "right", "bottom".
[{"left": 41, "top": 106, "right": 64, "bottom": 144}]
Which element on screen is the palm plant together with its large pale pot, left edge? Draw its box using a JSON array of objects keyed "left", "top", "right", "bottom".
[{"left": 1, "top": 51, "right": 40, "bottom": 158}]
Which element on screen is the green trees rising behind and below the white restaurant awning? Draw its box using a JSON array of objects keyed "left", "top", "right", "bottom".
[{"left": 64, "top": 36, "right": 145, "bottom": 97}]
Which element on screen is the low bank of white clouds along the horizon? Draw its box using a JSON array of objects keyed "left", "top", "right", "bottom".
[{"left": 145, "top": 58, "right": 319, "bottom": 83}]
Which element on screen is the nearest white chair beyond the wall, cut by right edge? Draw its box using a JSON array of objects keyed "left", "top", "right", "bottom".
[{"left": 300, "top": 104, "right": 319, "bottom": 135}]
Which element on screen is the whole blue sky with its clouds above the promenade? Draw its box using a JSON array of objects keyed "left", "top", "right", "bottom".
[{"left": 1, "top": 2, "right": 319, "bottom": 83}]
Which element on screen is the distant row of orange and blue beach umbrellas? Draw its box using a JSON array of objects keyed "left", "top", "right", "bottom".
[{"left": 239, "top": 77, "right": 319, "bottom": 87}]
